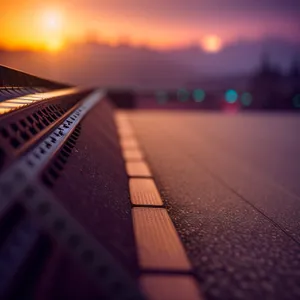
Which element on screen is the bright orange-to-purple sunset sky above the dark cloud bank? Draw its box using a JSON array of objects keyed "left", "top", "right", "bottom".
[{"left": 0, "top": 0, "right": 300, "bottom": 52}]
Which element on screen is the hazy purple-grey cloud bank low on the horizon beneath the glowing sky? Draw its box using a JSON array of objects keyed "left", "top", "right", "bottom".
[{"left": 0, "top": 38, "right": 300, "bottom": 88}]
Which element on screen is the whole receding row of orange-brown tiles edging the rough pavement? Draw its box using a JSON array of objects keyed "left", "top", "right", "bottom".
[{"left": 115, "top": 112, "right": 202, "bottom": 300}]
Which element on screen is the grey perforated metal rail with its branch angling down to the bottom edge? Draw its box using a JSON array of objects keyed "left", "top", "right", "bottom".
[{"left": 0, "top": 90, "right": 144, "bottom": 300}]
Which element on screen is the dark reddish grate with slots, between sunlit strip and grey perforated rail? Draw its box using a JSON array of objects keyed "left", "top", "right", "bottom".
[{"left": 0, "top": 89, "right": 90, "bottom": 170}]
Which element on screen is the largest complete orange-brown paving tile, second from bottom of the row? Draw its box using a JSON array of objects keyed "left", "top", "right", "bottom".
[{"left": 132, "top": 207, "right": 191, "bottom": 272}]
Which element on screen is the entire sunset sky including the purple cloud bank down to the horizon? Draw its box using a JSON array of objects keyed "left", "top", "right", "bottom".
[{"left": 0, "top": 0, "right": 300, "bottom": 88}]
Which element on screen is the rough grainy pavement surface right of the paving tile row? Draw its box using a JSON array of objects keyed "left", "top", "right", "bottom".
[{"left": 130, "top": 111, "right": 300, "bottom": 299}]
